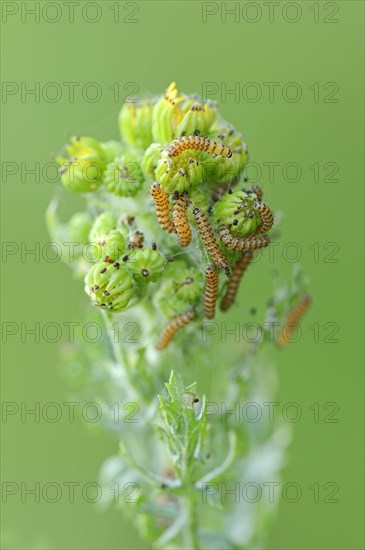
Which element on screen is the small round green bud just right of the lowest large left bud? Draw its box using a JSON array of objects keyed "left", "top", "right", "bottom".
[{"left": 127, "top": 248, "right": 167, "bottom": 282}]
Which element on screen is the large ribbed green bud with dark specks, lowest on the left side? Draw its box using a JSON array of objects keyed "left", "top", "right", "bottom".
[{"left": 85, "top": 262, "right": 135, "bottom": 312}]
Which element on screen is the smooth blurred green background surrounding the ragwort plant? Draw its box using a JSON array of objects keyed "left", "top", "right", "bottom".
[{"left": 1, "top": 1, "right": 364, "bottom": 549}]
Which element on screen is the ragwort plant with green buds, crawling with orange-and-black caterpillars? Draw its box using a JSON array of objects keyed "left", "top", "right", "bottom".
[{"left": 47, "top": 83, "right": 308, "bottom": 549}]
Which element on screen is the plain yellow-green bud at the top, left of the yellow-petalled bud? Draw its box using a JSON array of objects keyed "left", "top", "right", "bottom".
[{"left": 119, "top": 100, "right": 154, "bottom": 149}]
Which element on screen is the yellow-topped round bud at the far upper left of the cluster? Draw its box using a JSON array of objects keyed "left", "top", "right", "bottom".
[{"left": 58, "top": 137, "right": 106, "bottom": 193}]
